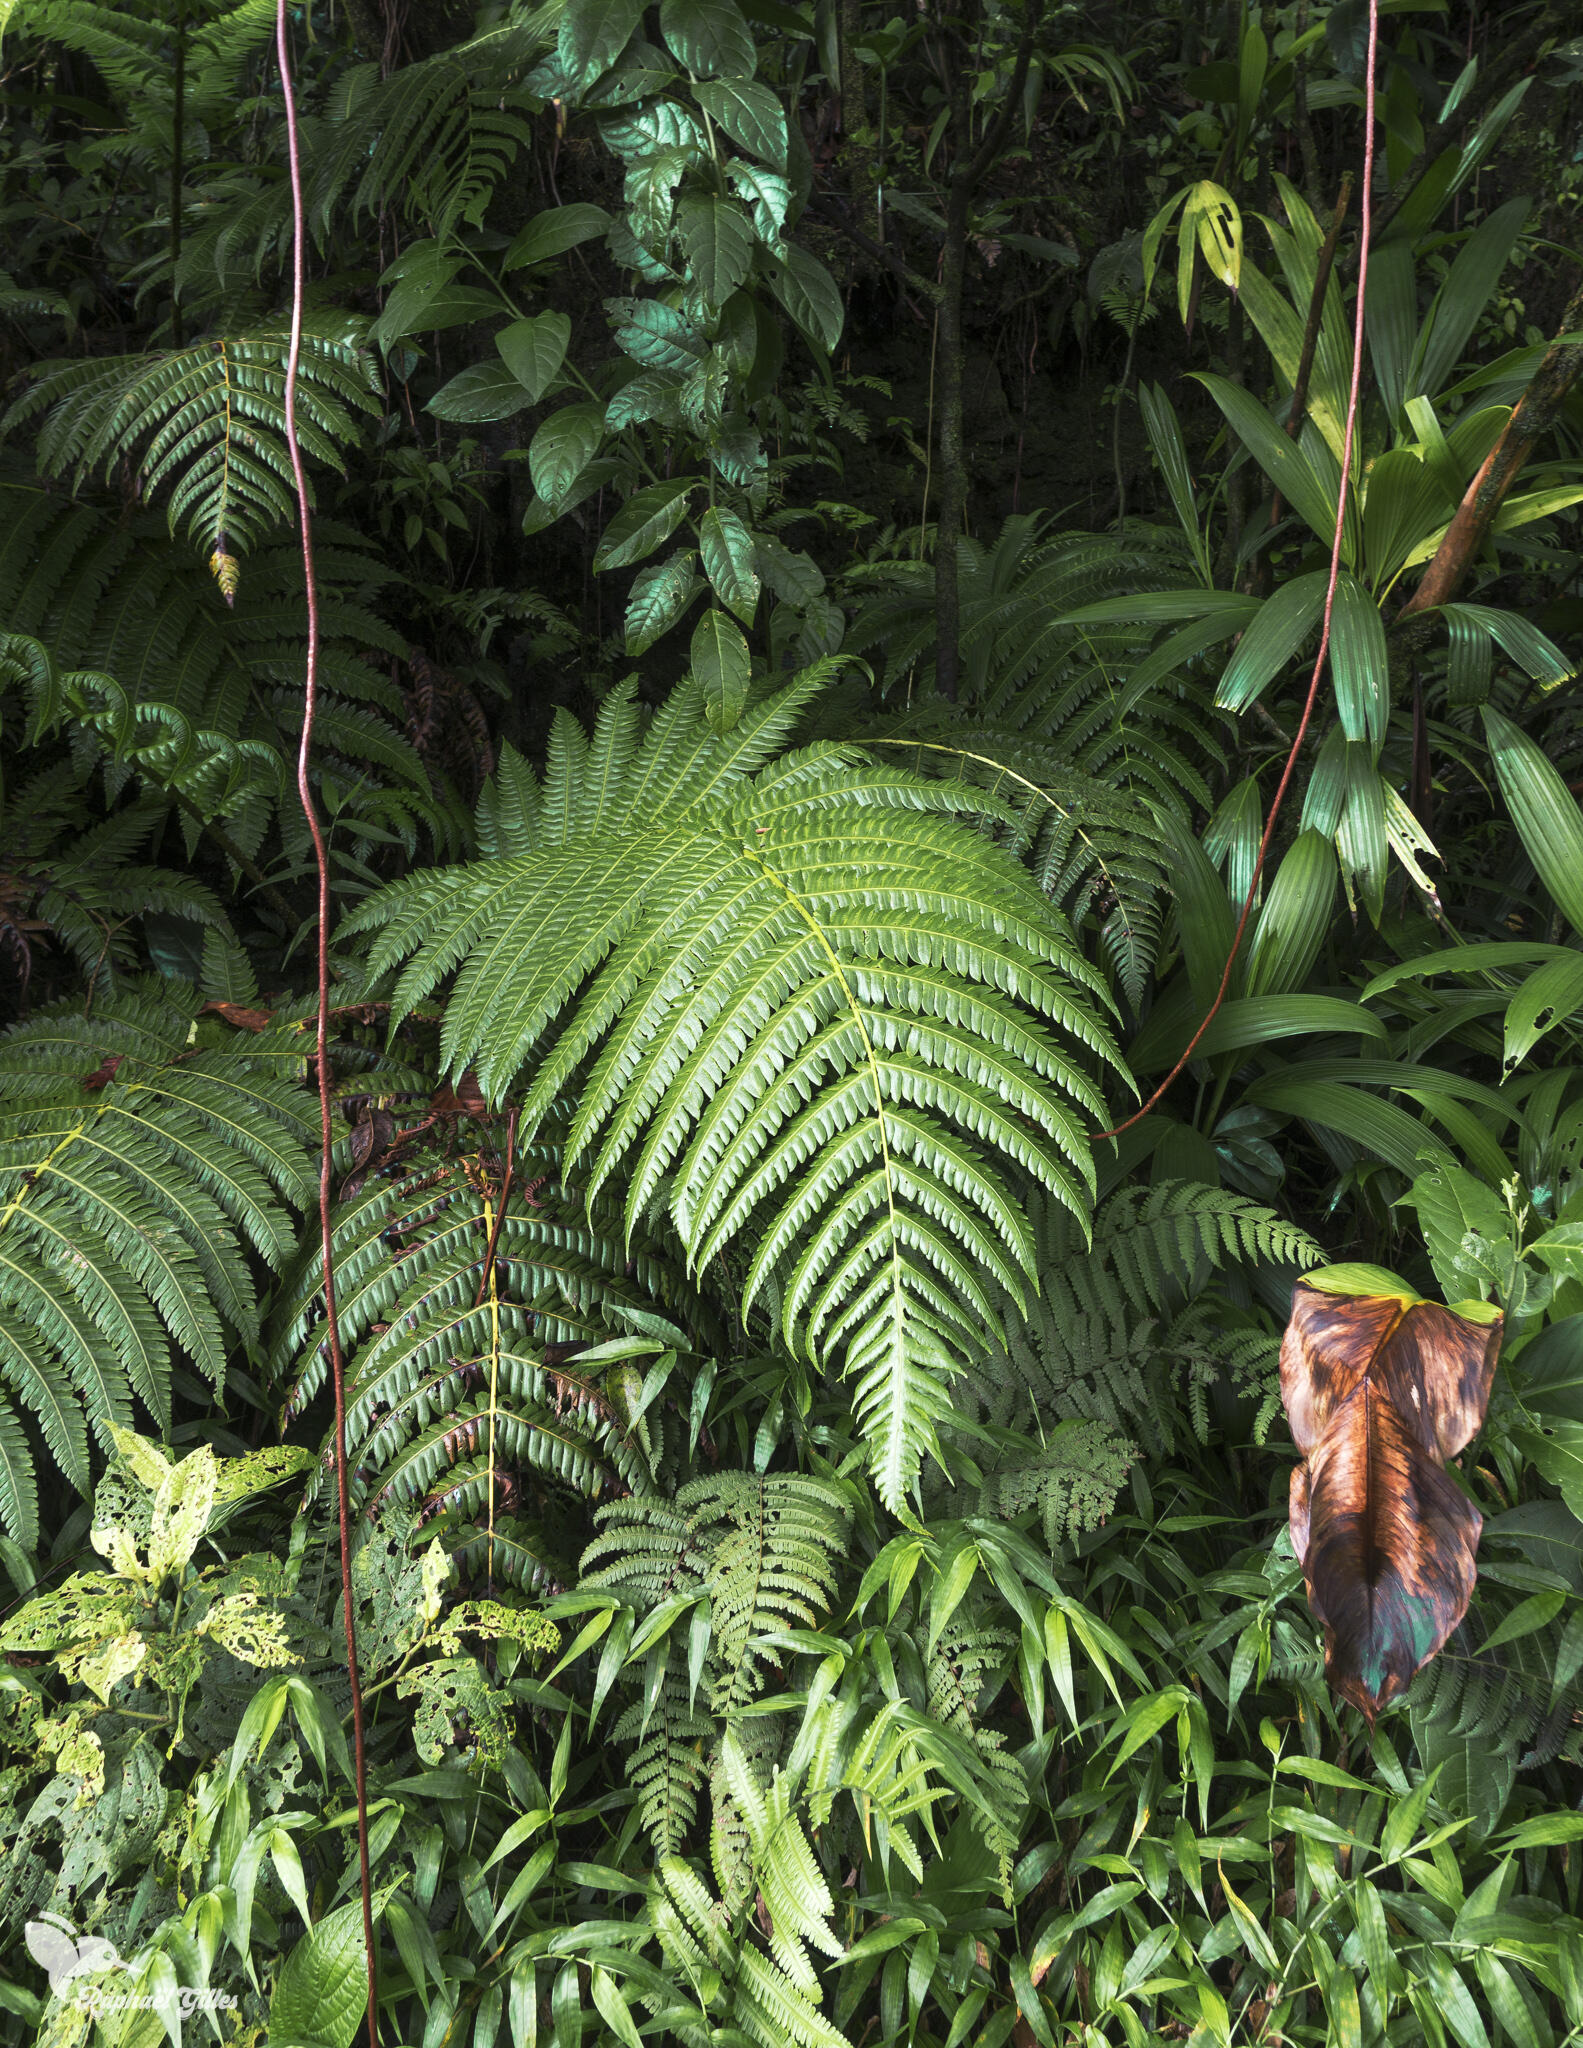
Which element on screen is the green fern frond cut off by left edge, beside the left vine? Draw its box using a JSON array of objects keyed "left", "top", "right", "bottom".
[{"left": 0, "top": 983, "right": 317, "bottom": 1546}]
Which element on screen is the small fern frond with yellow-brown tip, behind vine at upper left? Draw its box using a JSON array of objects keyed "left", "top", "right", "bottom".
[{"left": 0, "top": 334, "right": 379, "bottom": 565}]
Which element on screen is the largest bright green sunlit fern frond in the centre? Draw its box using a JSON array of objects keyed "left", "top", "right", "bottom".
[{"left": 346, "top": 674, "right": 1120, "bottom": 1503}]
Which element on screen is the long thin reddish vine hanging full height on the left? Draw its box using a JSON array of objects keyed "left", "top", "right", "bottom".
[{"left": 274, "top": 0, "right": 379, "bottom": 2048}]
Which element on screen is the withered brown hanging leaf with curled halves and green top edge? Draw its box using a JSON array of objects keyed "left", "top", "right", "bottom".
[{"left": 1280, "top": 1266, "right": 1501, "bottom": 1722}]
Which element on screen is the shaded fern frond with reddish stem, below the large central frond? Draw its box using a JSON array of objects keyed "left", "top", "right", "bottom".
[{"left": 274, "top": 1124, "right": 721, "bottom": 1583}]
